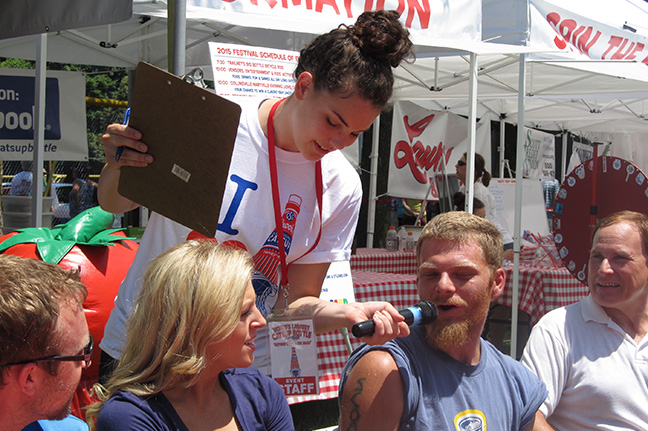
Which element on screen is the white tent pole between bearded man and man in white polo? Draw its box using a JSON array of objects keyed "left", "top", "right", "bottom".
[{"left": 511, "top": 54, "right": 526, "bottom": 359}]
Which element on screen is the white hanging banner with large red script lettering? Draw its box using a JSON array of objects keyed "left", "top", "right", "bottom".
[{"left": 387, "top": 101, "right": 490, "bottom": 200}]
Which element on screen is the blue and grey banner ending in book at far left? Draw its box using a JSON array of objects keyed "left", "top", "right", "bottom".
[{"left": 0, "top": 69, "right": 88, "bottom": 160}]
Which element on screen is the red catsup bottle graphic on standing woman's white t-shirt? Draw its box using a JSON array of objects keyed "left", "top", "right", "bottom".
[{"left": 253, "top": 195, "right": 302, "bottom": 285}]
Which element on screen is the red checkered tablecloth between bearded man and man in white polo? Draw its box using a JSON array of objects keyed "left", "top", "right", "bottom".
[{"left": 494, "top": 264, "right": 589, "bottom": 325}]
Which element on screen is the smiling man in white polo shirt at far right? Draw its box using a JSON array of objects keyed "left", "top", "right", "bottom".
[{"left": 522, "top": 211, "right": 648, "bottom": 431}]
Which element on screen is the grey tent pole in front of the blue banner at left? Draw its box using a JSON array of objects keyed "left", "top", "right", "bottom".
[{"left": 32, "top": 33, "right": 49, "bottom": 227}]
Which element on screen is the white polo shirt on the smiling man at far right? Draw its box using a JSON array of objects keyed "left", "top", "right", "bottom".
[{"left": 522, "top": 295, "right": 648, "bottom": 431}]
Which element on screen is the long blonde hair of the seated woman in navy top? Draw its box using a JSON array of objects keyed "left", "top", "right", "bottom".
[{"left": 86, "top": 240, "right": 253, "bottom": 429}]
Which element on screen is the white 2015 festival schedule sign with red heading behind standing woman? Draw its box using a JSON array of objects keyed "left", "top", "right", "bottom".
[{"left": 209, "top": 42, "right": 299, "bottom": 100}]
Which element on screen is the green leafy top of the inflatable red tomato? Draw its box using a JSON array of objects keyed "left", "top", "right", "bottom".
[{"left": 0, "top": 206, "right": 135, "bottom": 264}]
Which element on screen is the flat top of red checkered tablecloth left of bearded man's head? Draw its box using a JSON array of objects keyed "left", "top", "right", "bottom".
[{"left": 351, "top": 248, "right": 416, "bottom": 274}]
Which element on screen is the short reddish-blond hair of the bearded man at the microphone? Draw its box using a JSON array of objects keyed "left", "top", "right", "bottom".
[{"left": 416, "top": 211, "right": 504, "bottom": 272}]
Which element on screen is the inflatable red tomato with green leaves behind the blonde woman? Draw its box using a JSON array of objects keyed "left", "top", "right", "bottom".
[{"left": 0, "top": 207, "right": 138, "bottom": 419}]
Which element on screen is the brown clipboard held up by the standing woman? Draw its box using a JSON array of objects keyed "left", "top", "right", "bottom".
[{"left": 118, "top": 62, "right": 241, "bottom": 238}]
